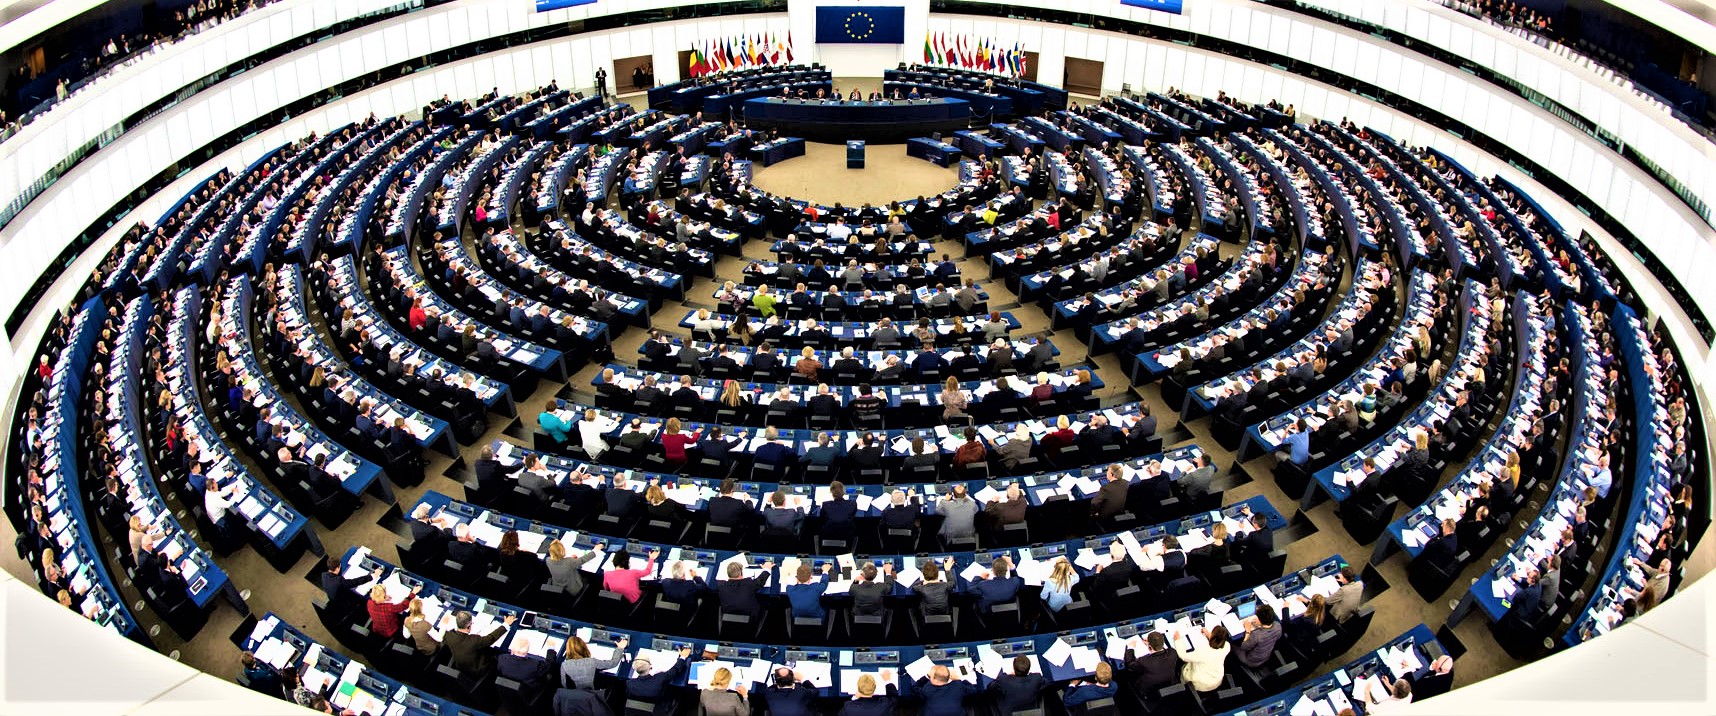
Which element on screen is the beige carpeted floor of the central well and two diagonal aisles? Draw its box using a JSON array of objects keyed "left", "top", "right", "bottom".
[{"left": 0, "top": 87, "right": 1541, "bottom": 697}]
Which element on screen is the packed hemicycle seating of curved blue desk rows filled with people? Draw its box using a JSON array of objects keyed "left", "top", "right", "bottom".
[{"left": 9, "top": 72, "right": 1702, "bottom": 713}]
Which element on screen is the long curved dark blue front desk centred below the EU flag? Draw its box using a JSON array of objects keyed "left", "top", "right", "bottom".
[{"left": 745, "top": 98, "right": 971, "bottom": 143}]
